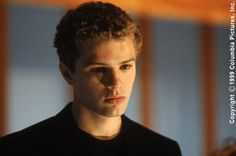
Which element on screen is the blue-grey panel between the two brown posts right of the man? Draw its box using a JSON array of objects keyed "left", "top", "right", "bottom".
[{"left": 153, "top": 21, "right": 202, "bottom": 156}]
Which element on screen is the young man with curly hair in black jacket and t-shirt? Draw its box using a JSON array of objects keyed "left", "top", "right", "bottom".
[{"left": 0, "top": 2, "right": 181, "bottom": 156}]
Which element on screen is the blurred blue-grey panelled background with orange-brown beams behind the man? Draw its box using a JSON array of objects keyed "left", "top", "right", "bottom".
[{"left": 0, "top": 0, "right": 233, "bottom": 156}]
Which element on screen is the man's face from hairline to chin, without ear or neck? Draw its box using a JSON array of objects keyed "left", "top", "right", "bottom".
[{"left": 72, "top": 37, "right": 136, "bottom": 117}]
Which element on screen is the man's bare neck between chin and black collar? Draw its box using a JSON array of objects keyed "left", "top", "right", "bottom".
[{"left": 72, "top": 103, "right": 121, "bottom": 140}]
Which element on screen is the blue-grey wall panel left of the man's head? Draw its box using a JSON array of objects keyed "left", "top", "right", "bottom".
[{"left": 8, "top": 5, "right": 67, "bottom": 133}]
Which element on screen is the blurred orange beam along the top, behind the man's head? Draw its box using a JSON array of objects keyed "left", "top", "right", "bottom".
[{"left": 8, "top": 0, "right": 231, "bottom": 25}]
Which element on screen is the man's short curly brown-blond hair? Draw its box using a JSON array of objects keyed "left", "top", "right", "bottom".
[{"left": 54, "top": 2, "right": 142, "bottom": 71}]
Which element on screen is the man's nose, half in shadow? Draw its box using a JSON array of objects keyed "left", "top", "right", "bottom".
[{"left": 107, "top": 70, "right": 121, "bottom": 91}]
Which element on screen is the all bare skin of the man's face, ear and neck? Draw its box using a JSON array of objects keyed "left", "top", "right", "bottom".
[{"left": 60, "top": 37, "right": 136, "bottom": 140}]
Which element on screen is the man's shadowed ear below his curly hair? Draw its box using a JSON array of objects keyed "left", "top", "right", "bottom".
[{"left": 59, "top": 61, "right": 74, "bottom": 85}]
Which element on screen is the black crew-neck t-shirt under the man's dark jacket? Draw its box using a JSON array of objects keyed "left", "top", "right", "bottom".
[{"left": 80, "top": 130, "right": 121, "bottom": 156}]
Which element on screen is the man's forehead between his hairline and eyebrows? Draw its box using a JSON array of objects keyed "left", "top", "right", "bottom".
[{"left": 78, "top": 37, "right": 136, "bottom": 64}]
